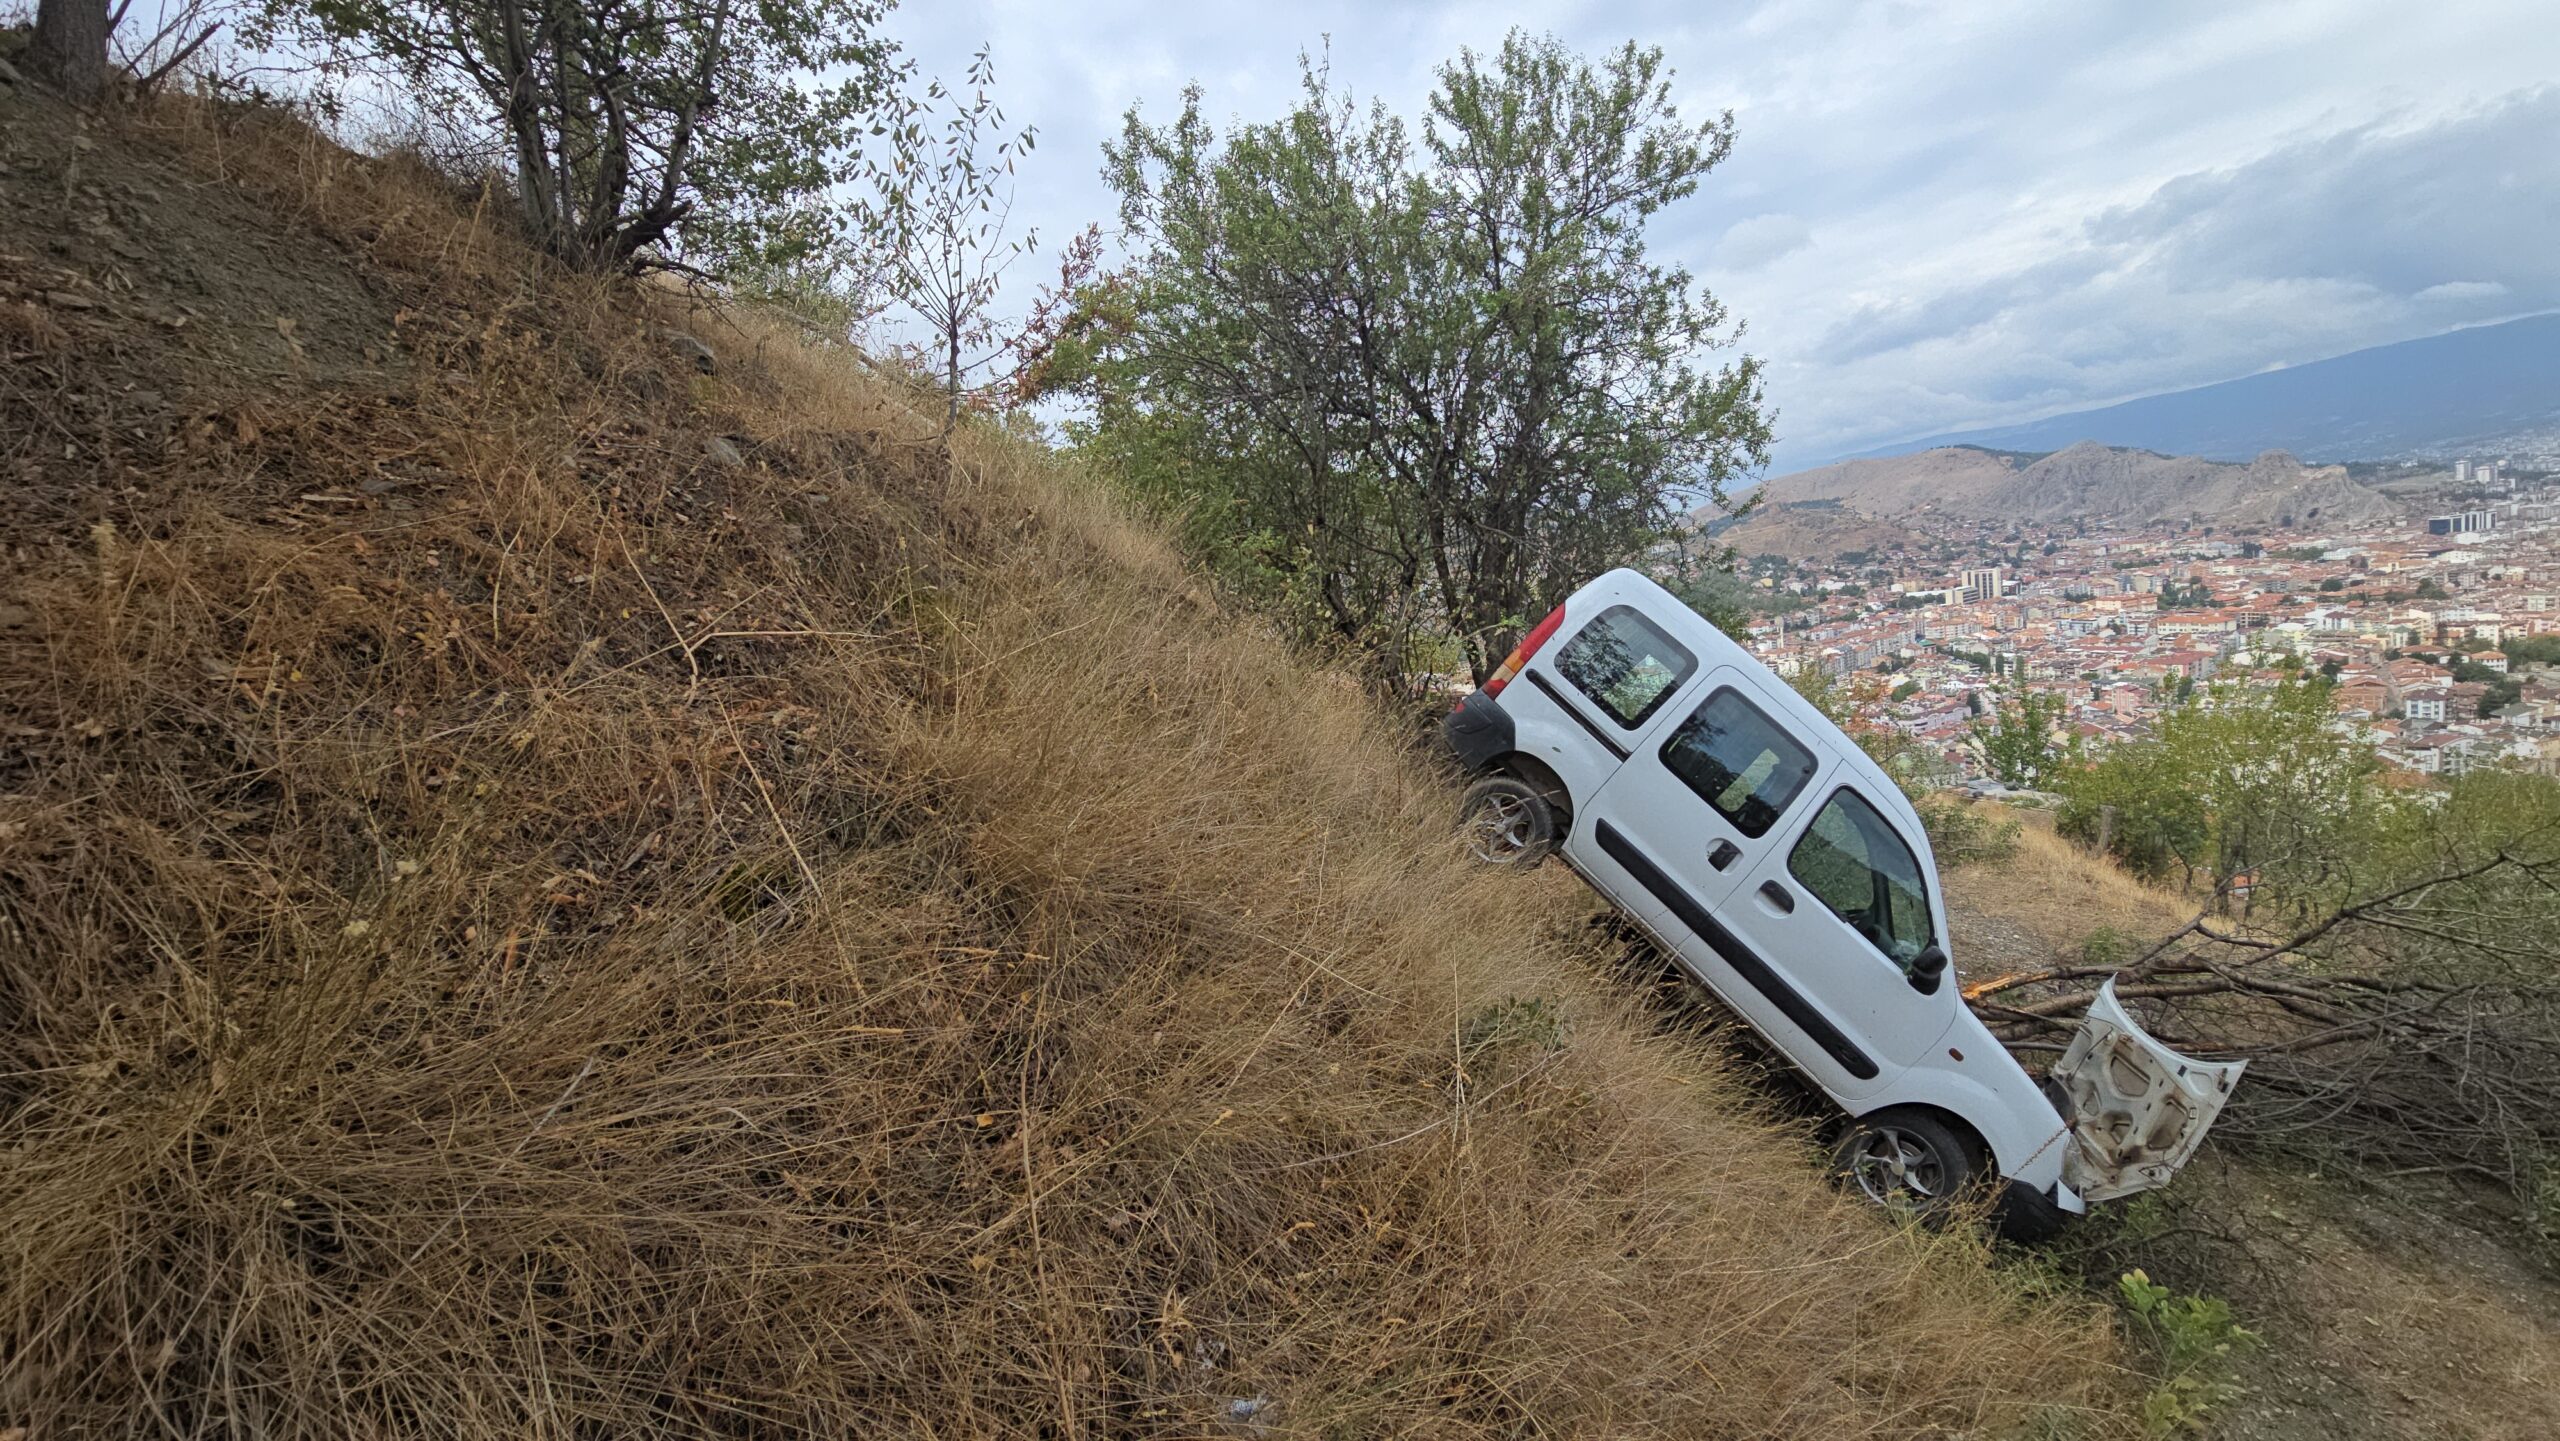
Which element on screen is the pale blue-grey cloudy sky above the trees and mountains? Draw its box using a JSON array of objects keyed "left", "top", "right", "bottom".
[{"left": 891, "top": 0, "right": 2560, "bottom": 471}]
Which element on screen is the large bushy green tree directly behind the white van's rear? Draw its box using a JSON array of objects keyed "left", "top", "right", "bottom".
[{"left": 1052, "top": 33, "right": 1769, "bottom": 681}]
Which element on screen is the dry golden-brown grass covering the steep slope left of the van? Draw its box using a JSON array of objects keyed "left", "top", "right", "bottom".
[{"left": 0, "top": 87, "right": 2120, "bottom": 1438}]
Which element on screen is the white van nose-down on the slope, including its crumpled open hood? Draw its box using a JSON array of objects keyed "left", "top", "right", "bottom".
[{"left": 1444, "top": 571, "right": 2240, "bottom": 1234}]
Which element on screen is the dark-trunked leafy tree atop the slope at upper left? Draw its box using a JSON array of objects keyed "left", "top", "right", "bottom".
[{"left": 251, "top": 0, "right": 901, "bottom": 271}]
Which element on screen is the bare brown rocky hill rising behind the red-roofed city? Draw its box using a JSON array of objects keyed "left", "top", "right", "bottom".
[{"left": 1766, "top": 440, "right": 2399, "bottom": 525}]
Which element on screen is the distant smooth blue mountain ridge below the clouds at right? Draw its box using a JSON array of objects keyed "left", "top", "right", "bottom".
[{"left": 1812, "top": 312, "right": 2560, "bottom": 461}]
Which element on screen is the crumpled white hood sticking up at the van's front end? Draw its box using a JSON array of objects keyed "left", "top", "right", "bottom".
[{"left": 2053, "top": 980, "right": 2248, "bottom": 1200}]
